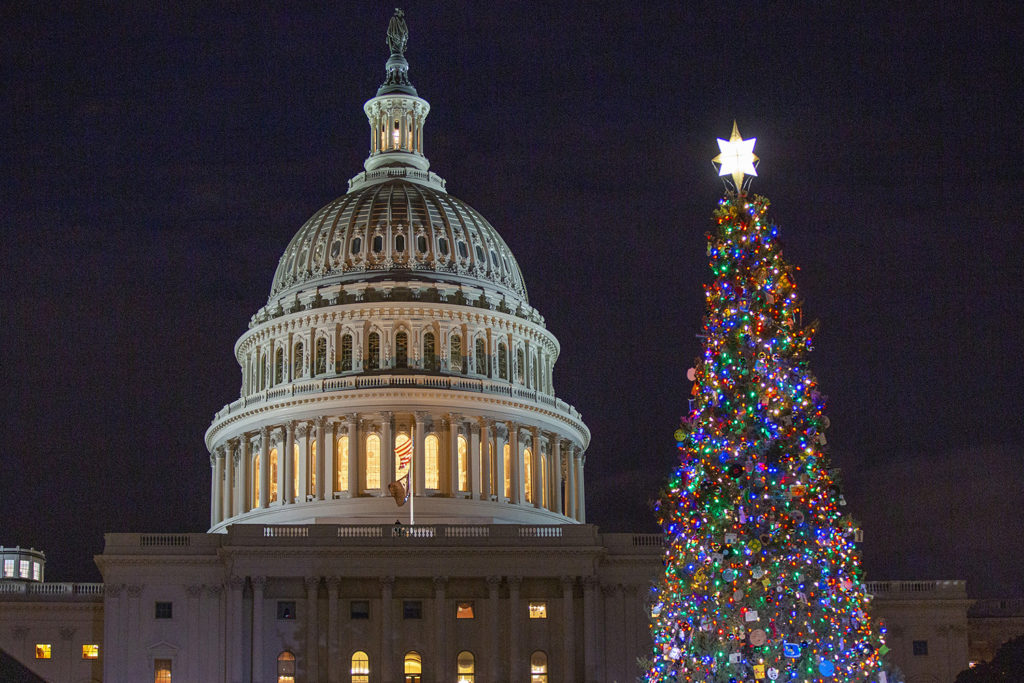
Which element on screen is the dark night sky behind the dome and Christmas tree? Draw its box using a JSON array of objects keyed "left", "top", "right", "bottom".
[{"left": 0, "top": 1, "right": 1024, "bottom": 596}]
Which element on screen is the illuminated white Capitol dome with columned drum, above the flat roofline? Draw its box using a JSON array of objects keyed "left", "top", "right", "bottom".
[{"left": 206, "top": 14, "right": 590, "bottom": 531}]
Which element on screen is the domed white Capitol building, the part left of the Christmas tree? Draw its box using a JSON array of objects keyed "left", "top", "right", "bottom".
[{"left": 0, "top": 11, "right": 662, "bottom": 683}]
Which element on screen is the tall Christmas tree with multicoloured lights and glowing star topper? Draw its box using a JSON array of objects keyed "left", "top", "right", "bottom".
[{"left": 647, "top": 124, "right": 887, "bottom": 683}]
